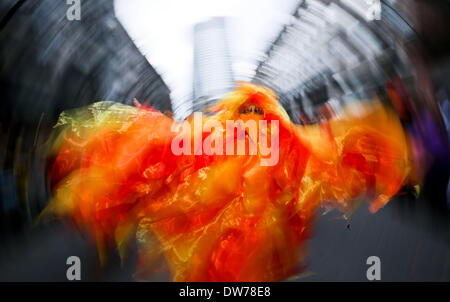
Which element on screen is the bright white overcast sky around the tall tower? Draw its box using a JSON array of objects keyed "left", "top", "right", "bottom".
[{"left": 115, "top": 0, "right": 299, "bottom": 118}]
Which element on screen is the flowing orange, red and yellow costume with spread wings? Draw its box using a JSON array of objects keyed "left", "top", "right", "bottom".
[{"left": 45, "top": 83, "right": 410, "bottom": 281}]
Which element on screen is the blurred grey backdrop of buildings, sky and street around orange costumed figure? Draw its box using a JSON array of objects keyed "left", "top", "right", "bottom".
[{"left": 0, "top": 0, "right": 450, "bottom": 281}]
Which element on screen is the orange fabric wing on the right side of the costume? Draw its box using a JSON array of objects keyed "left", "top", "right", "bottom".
[{"left": 296, "top": 102, "right": 412, "bottom": 216}]
